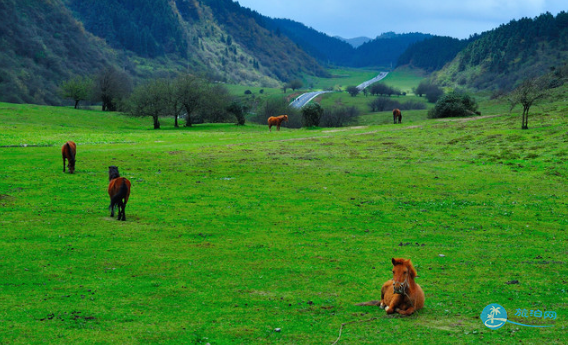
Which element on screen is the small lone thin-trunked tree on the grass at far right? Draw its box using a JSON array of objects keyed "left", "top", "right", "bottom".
[{"left": 509, "top": 77, "right": 549, "bottom": 129}]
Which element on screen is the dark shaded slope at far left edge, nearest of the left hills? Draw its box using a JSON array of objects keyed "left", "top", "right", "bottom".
[{"left": 0, "top": 0, "right": 113, "bottom": 104}]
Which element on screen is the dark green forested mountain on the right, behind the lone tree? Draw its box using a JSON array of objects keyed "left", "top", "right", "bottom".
[{"left": 434, "top": 12, "right": 568, "bottom": 90}]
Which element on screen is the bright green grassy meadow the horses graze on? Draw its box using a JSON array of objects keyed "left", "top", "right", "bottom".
[{"left": 0, "top": 84, "right": 568, "bottom": 344}]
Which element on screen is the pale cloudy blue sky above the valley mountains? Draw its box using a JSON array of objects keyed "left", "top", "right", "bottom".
[{"left": 238, "top": 0, "right": 568, "bottom": 38}]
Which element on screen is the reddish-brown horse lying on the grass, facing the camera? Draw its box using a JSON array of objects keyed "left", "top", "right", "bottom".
[{"left": 357, "top": 258, "right": 424, "bottom": 315}]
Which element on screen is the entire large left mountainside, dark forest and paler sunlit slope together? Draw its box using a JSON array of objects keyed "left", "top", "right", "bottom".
[{"left": 0, "top": 0, "right": 327, "bottom": 104}]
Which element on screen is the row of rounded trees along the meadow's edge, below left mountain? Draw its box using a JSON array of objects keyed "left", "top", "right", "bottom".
[{"left": 60, "top": 67, "right": 246, "bottom": 129}]
